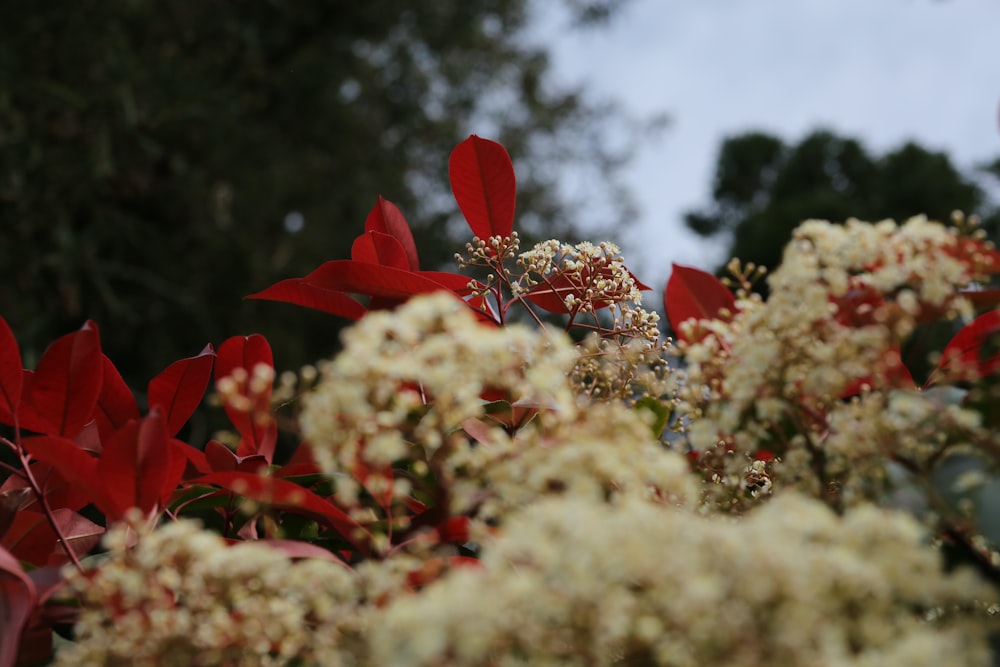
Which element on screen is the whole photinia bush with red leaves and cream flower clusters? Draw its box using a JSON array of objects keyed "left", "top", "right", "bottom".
[{"left": 0, "top": 136, "right": 1000, "bottom": 667}]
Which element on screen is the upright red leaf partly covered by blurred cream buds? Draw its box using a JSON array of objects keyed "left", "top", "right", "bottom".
[{"left": 215, "top": 334, "right": 278, "bottom": 463}]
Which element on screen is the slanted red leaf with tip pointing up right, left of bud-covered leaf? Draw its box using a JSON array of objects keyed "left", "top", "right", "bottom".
[{"left": 148, "top": 345, "right": 215, "bottom": 436}]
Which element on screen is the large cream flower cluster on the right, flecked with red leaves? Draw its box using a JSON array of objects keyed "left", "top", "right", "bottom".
[{"left": 679, "top": 217, "right": 996, "bottom": 504}]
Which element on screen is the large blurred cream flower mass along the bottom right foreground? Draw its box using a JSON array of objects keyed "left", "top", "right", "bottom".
[{"left": 370, "top": 494, "right": 990, "bottom": 667}]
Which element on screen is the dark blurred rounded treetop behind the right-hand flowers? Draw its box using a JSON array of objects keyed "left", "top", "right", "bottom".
[{"left": 685, "top": 131, "right": 1000, "bottom": 287}]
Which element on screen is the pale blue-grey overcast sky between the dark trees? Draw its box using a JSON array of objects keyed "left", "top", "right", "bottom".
[{"left": 539, "top": 0, "right": 1000, "bottom": 285}]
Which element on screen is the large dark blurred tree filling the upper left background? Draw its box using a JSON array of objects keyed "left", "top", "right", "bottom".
[{"left": 0, "top": 0, "right": 644, "bottom": 385}]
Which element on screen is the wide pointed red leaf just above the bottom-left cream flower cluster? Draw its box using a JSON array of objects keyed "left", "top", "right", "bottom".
[{"left": 97, "top": 409, "right": 174, "bottom": 519}]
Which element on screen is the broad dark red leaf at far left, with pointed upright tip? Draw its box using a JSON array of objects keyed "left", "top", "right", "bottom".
[{"left": 19, "top": 321, "right": 104, "bottom": 438}]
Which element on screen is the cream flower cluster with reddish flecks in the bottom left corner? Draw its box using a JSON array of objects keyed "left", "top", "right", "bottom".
[{"left": 55, "top": 521, "right": 361, "bottom": 667}]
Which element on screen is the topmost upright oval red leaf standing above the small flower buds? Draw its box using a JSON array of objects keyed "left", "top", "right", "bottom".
[{"left": 448, "top": 135, "right": 517, "bottom": 240}]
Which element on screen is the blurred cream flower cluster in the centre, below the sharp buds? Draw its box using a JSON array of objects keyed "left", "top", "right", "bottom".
[{"left": 301, "top": 294, "right": 693, "bottom": 528}]
